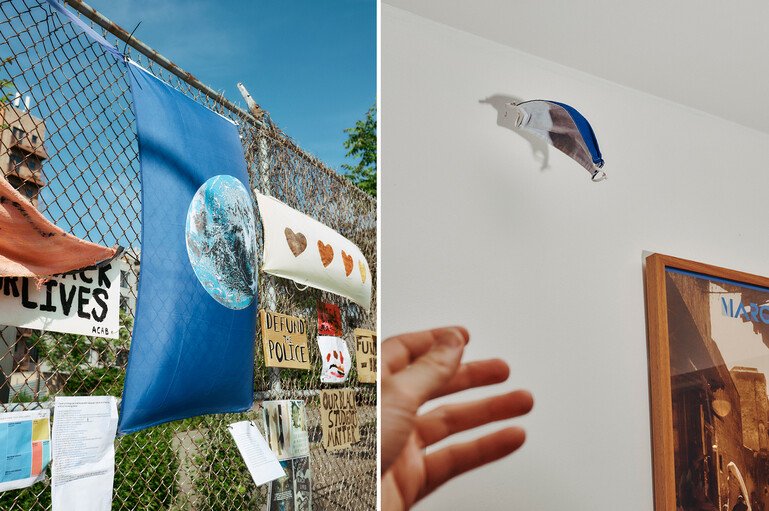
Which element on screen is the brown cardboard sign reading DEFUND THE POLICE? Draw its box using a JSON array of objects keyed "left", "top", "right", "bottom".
[{"left": 259, "top": 309, "right": 311, "bottom": 369}]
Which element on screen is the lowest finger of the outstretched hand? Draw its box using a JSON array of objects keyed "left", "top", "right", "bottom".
[{"left": 419, "top": 427, "right": 526, "bottom": 499}]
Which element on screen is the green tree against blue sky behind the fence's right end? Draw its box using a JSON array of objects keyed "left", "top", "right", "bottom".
[{"left": 342, "top": 104, "right": 377, "bottom": 197}]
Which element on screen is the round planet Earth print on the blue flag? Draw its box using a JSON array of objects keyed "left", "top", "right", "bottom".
[{"left": 186, "top": 175, "right": 257, "bottom": 310}]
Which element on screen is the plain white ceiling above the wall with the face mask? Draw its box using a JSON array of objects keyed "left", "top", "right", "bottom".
[{"left": 382, "top": 0, "right": 769, "bottom": 133}]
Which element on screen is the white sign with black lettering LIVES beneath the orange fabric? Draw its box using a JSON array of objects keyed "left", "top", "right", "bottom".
[{"left": 0, "top": 261, "right": 120, "bottom": 339}]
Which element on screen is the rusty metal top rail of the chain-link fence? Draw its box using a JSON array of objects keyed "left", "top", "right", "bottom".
[{"left": 63, "top": 0, "right": 375, "bottom": 208}]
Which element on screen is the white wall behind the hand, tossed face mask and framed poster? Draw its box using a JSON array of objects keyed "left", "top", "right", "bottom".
[{"left": 381, "top": 5, "right": 769, "bottom": 511}]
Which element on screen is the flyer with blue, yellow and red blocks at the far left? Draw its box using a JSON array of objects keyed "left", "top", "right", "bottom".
[{"left": 0, "top": 409, "right": 51, "bottom": 491}]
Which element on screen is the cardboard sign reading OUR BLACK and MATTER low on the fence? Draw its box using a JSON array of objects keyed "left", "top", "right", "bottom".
[{"left": 320, "top": 389, "right": 360, "bottom": 451}]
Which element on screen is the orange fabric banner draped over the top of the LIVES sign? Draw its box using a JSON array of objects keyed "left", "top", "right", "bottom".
[{"left": 0, "top": 177, "right": 118, "bottom": 277}]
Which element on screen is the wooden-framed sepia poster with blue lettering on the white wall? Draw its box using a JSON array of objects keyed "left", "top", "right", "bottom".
[{"left": 646, "top": 254, "right": 769, "bottom": 511}]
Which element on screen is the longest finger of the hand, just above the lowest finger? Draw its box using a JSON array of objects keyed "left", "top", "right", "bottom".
[{"left": 417, "top": 390, "right": 534, "bottom": 446}]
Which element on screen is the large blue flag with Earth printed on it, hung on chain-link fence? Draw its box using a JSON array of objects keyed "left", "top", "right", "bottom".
[{"left": 119, "top": 63, "right": 257, "bottom": 433}]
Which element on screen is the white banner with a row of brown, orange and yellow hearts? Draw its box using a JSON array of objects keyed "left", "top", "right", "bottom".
[{"left": 254, "top": 190, "right": 371, "bottom": 311}]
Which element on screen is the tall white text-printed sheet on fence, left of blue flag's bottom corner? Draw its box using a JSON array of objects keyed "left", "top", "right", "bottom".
[{"left": 51, "top": 396, "right": 118, "bottom": 511}]
